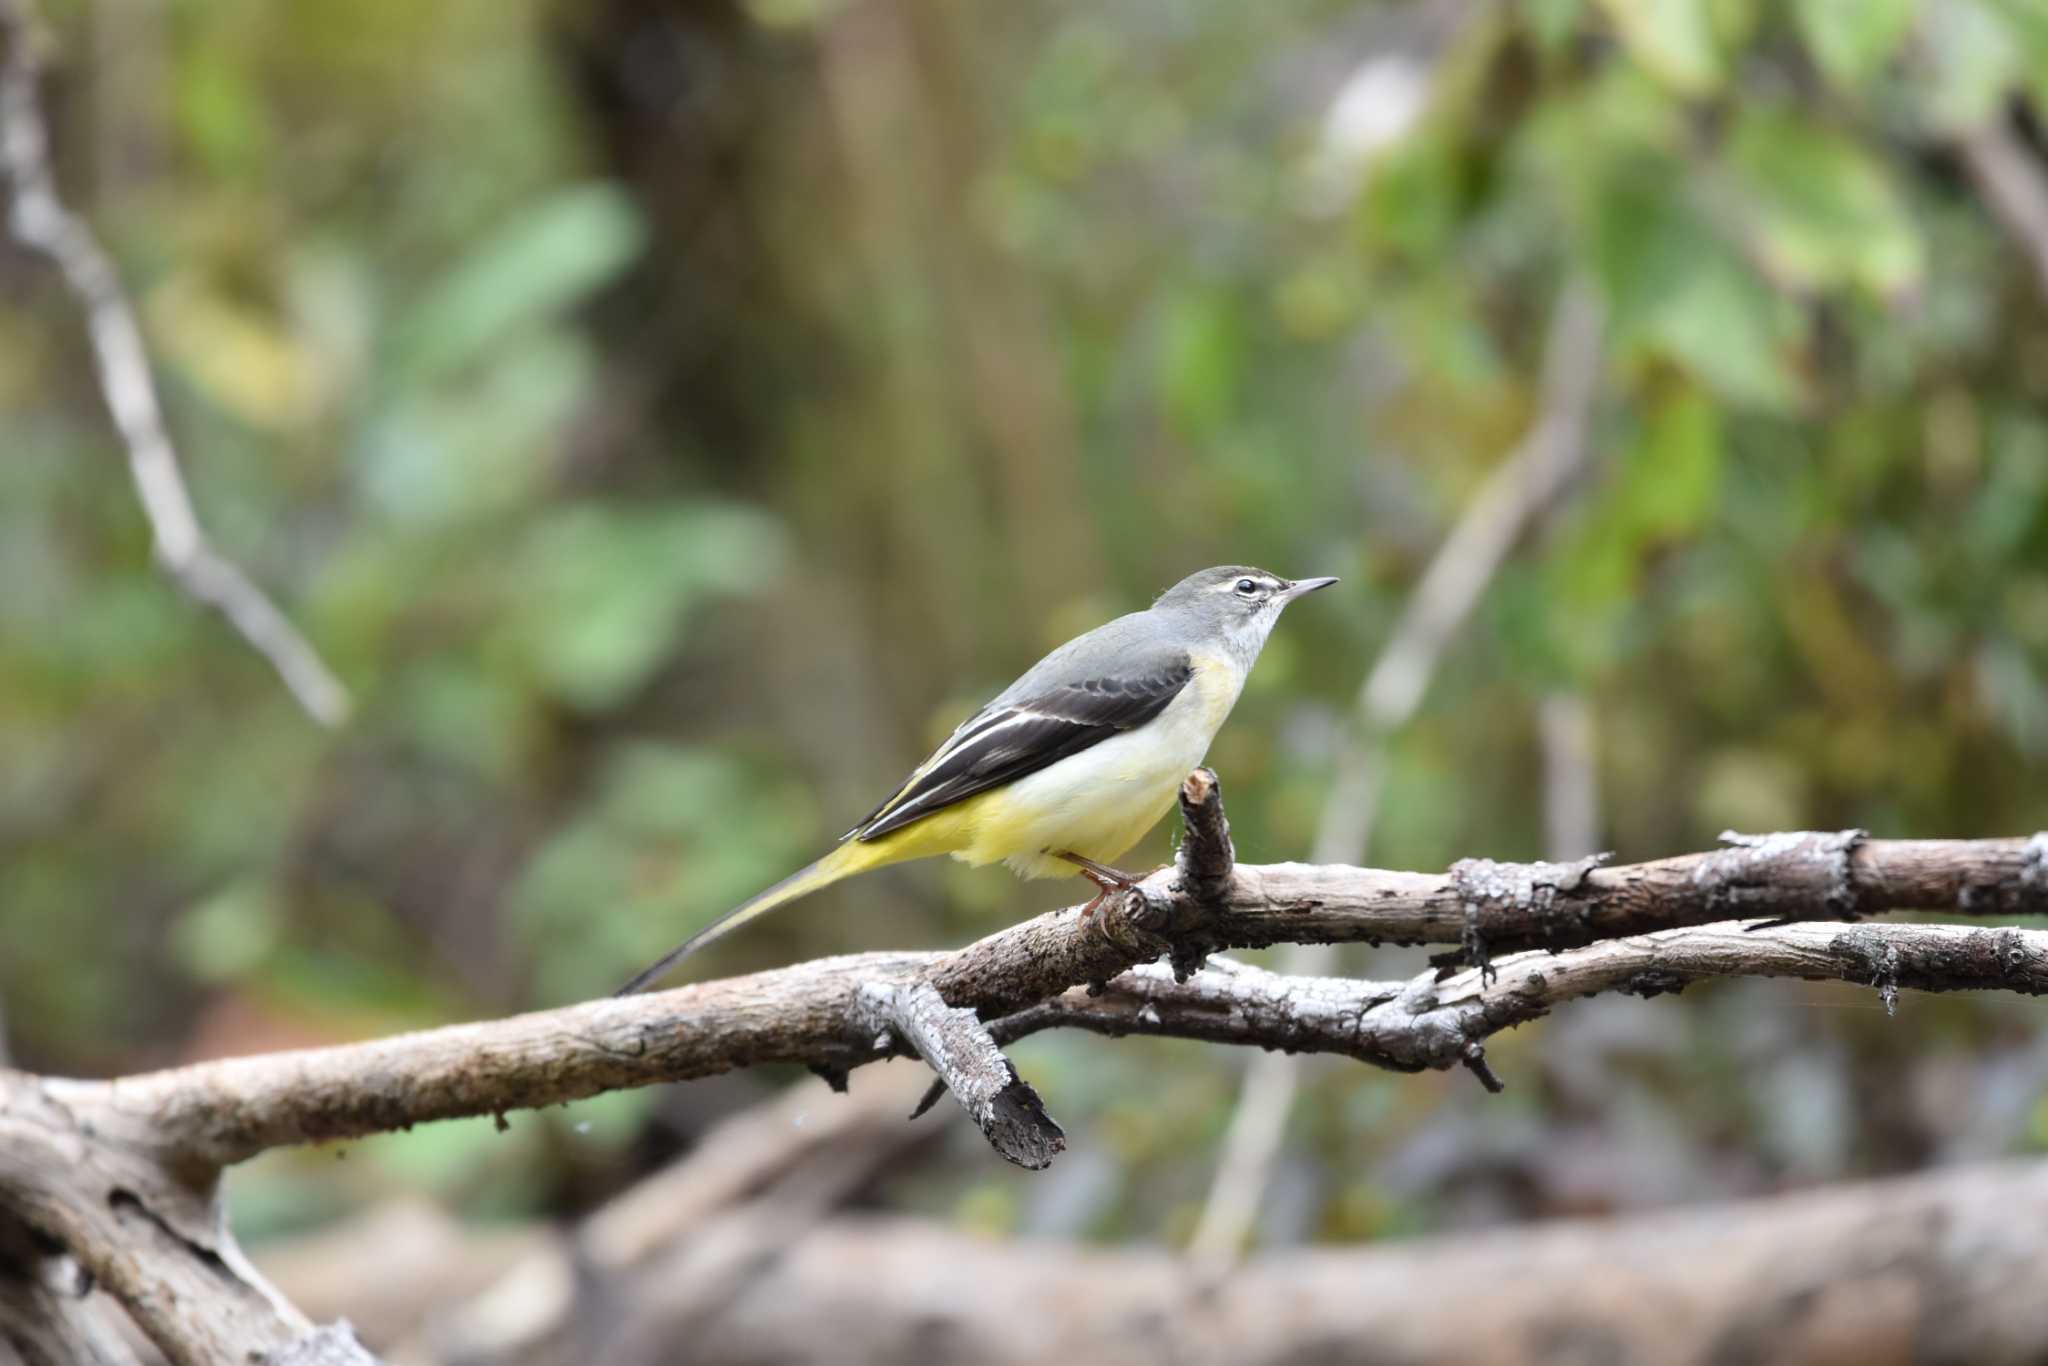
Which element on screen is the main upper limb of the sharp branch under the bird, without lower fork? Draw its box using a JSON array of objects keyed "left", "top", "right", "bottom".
[{"left": 28, "top": 819, "right": 2048, "bottom": 1165}]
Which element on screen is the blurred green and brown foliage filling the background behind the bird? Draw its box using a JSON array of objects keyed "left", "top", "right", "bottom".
[{"left": 0, "top": 0, "right": 2048, "bottom": 1237}]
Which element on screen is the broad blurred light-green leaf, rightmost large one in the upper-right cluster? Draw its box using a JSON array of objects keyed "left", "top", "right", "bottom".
[{"left": 1729, "top": 109, "right": 1925, "bottom": 297}]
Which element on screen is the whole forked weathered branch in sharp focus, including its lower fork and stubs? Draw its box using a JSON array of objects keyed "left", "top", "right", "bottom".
[{"left": 0, "top": 770, "right": 2048, "bottom": 1362}]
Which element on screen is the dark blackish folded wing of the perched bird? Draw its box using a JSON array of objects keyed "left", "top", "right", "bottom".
[{"left": 848, "top": 651, "right": 1194, "bottom": 840}]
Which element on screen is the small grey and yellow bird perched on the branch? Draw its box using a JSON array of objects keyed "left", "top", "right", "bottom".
[{"left": 618, "top": 565, "right": 1337, "bottom": 995}]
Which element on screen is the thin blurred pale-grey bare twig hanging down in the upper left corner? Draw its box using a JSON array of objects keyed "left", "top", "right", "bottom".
[{"left": 0, "top": 0, "right": 348, "bottom": 725}]
